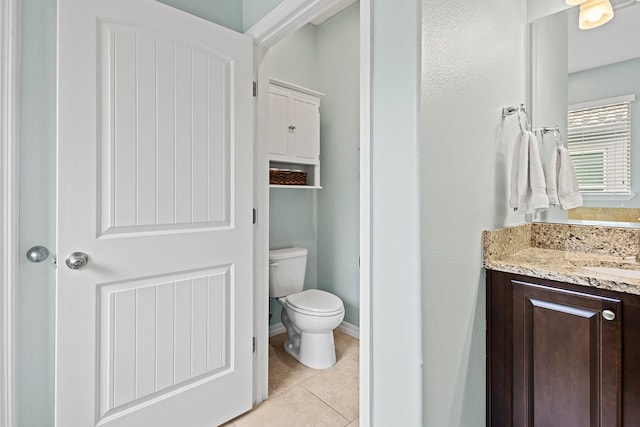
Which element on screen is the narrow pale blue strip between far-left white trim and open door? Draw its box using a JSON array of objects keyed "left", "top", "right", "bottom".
[{"left": 17, "top": 0, "right": 56, "bottom": 427}]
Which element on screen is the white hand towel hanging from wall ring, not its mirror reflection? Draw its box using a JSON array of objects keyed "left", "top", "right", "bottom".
[{"left": 509, "top": 131, "right": 549, "bottom": 213}]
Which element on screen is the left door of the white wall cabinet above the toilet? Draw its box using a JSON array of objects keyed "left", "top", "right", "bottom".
[{"left": 269, "top": 87, "right": 291, "bottom": 160}]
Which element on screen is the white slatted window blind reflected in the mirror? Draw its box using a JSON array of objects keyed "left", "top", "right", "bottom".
[{"left": 567, "top": 96, "right": 635, "bottom": 195}]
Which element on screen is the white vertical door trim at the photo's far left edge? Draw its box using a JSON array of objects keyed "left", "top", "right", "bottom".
[{"left": 0, "top": 0, "right": 20, "bottom": 427}]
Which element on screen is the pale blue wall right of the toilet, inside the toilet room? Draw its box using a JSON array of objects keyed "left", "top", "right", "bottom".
[{"left": 316, "top": 3, "right": 360, "bottom": 325}]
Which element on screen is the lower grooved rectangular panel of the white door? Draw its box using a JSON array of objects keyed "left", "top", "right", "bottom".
[{"left": 99, "top": 266, "right": 232, "bottom": 416}]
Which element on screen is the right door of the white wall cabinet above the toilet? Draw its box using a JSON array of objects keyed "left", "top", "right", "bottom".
[{"left": 291, "top": 94, "right": 320, "bottom": 163}]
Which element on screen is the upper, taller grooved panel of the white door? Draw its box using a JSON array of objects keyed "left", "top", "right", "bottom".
[{"left": 99, "top": 21, "right": 233, "bottom": 234}]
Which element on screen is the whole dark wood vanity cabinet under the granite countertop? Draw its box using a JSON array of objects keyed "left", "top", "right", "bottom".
[{"left": 487, "top": 270, "right": 640, "bottom": 427}]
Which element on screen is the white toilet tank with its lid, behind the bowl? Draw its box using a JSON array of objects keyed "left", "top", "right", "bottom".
[{"left": 269, "top": 248, "right": 307, "bottom": 298}]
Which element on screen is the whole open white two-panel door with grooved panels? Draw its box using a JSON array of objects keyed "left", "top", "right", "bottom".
[{"left": 56, "top": 0, "right": 253, "bottom": 427}]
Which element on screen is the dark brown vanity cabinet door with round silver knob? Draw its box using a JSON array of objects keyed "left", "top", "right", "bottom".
[{"left": 512, "top": 281, "right": 622, "bottom": 427}]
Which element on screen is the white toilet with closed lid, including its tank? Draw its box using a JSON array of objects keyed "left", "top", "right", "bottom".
[{"left": 269, "top": 248, "right": 344, "bottom": 369}]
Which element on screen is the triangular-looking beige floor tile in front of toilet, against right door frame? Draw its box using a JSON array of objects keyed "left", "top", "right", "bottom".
[{"left": 300, "top": 357, "right": 360, "bottom": 421}]
